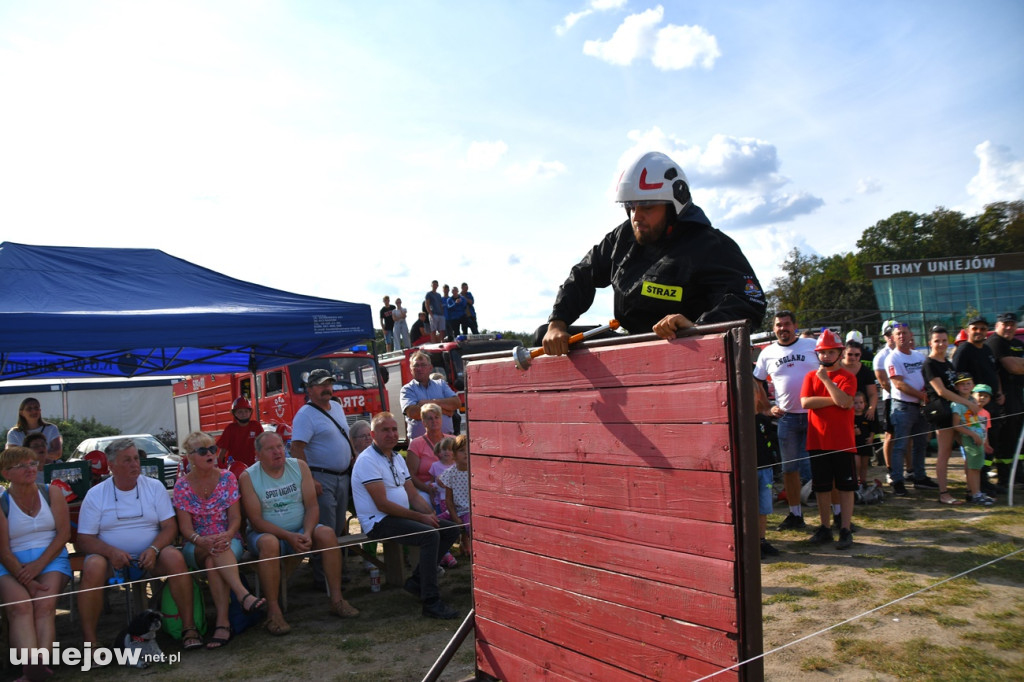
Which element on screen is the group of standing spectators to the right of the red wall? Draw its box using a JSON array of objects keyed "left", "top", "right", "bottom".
[{"left": 754, "top": 310, "right": 1024, "bottom": 559}]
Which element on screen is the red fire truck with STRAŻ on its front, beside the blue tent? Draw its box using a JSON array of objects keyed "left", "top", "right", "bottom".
[{"left": 173, "top": 346, "right": 387, "bottom": 445}]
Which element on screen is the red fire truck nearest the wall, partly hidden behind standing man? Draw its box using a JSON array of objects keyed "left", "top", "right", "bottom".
[{"left": 380, "top": 334, "right": 522, "bottom": 438}]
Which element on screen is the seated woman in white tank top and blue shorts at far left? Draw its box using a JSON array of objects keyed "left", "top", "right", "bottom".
[{"left": 0, "top": 446, "right": 71, "bottom": 680}]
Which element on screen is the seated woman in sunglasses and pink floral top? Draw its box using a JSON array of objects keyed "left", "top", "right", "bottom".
[{"left": 171, "top": 432, "right": 266, "bottom": 649}]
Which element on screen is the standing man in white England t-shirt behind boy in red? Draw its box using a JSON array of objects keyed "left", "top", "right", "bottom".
[{"left": 754, "top": 310, "right": 818, "bottom": 530}]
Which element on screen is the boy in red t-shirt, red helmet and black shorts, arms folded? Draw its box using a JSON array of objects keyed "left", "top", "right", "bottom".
[{"left": 800, "top": 329, "right": 857, "bottom": 549}]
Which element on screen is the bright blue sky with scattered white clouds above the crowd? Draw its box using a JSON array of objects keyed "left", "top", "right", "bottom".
[{"left": 0, "top": 0, "right": 1024, "bottom": 331}]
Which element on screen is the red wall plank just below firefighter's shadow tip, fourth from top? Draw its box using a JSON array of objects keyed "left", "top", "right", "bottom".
[{"left": 471, "top": 455, "right": 732, "bottom": 523}]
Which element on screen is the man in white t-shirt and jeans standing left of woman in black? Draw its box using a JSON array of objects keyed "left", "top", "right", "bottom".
[{"left": 886, "top": 324, "right": 939, "bottom": 497}]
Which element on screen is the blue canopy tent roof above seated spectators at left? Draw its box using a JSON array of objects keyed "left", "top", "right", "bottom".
[{"left": 0, "top": 242, "right": 374, "bottom": 380}]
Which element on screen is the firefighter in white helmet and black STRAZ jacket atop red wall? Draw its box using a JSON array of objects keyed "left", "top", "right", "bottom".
[{"left": 538, "top": 152, "right": 765, "bottom": 355}]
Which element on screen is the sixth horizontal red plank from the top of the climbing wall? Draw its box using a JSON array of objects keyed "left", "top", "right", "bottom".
[{"left": 473, "top": 513, "right": 735, "bottom": 596}]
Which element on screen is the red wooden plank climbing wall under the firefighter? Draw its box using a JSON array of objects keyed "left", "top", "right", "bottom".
[{"left": 467, "top": 329, "right": 761, "bottom": 681}]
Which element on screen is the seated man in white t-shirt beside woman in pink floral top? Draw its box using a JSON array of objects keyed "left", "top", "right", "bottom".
[{"left": 75, "top": 438, "right": 203, "bottom": 649}]
